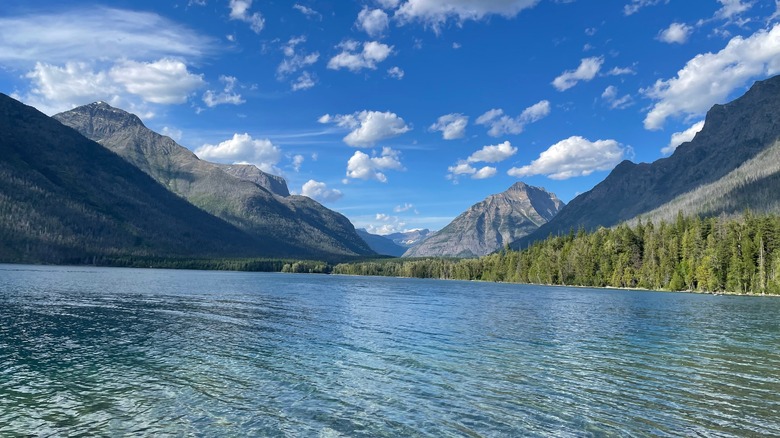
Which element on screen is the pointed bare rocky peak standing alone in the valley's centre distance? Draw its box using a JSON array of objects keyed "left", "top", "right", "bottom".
[{"left": 404, "top": 182, "right": 564, "bottom": 257}]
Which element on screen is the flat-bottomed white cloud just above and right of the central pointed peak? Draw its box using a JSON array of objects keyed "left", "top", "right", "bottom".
[{"left": 507, "top": 136, "right": 626, "bottom": 179}]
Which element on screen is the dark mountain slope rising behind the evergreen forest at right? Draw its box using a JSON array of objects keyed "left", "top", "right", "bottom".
[{"left": 512, "top": 76, "right": 780, "bottom": 248}]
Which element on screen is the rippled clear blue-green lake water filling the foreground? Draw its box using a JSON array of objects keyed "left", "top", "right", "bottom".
[{"left": 0, "top": 265, "right": 780, "bottom": 437}]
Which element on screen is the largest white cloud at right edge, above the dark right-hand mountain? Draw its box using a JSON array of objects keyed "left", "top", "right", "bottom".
[{"left": 641, "top": 24, "right": 780, "bottom": 129}]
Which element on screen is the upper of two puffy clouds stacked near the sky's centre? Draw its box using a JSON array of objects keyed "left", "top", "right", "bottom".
[{"left": 319, "top": 111, "right": 412, "bottom": 147}]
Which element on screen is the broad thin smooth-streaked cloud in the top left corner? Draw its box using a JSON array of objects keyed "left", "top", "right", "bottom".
[{"left": 0, "top": 7, "right": 215, "bottom": 68}]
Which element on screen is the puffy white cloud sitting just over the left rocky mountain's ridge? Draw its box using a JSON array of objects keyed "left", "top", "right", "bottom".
[{"left": 195, "top": 133, "right": 282, "bottom": 175}]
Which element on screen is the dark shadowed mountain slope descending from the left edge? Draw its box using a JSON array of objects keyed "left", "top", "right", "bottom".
[{"left": 0, "top": 94, "right": 274, "bottom": 263}]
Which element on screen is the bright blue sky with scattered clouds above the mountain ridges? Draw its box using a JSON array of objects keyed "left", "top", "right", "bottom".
[{"left": 0, "top": 0, "right": 780, "bottom": 234}]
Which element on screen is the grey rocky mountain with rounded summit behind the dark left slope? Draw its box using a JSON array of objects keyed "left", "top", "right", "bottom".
[{"left": 54, "top": 102, "right": 373, "bottom": 258}]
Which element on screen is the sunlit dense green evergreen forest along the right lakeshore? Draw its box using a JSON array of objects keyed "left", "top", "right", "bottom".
[{"left": 332, "top": 212, "right": 780, "bottom": 294}]
